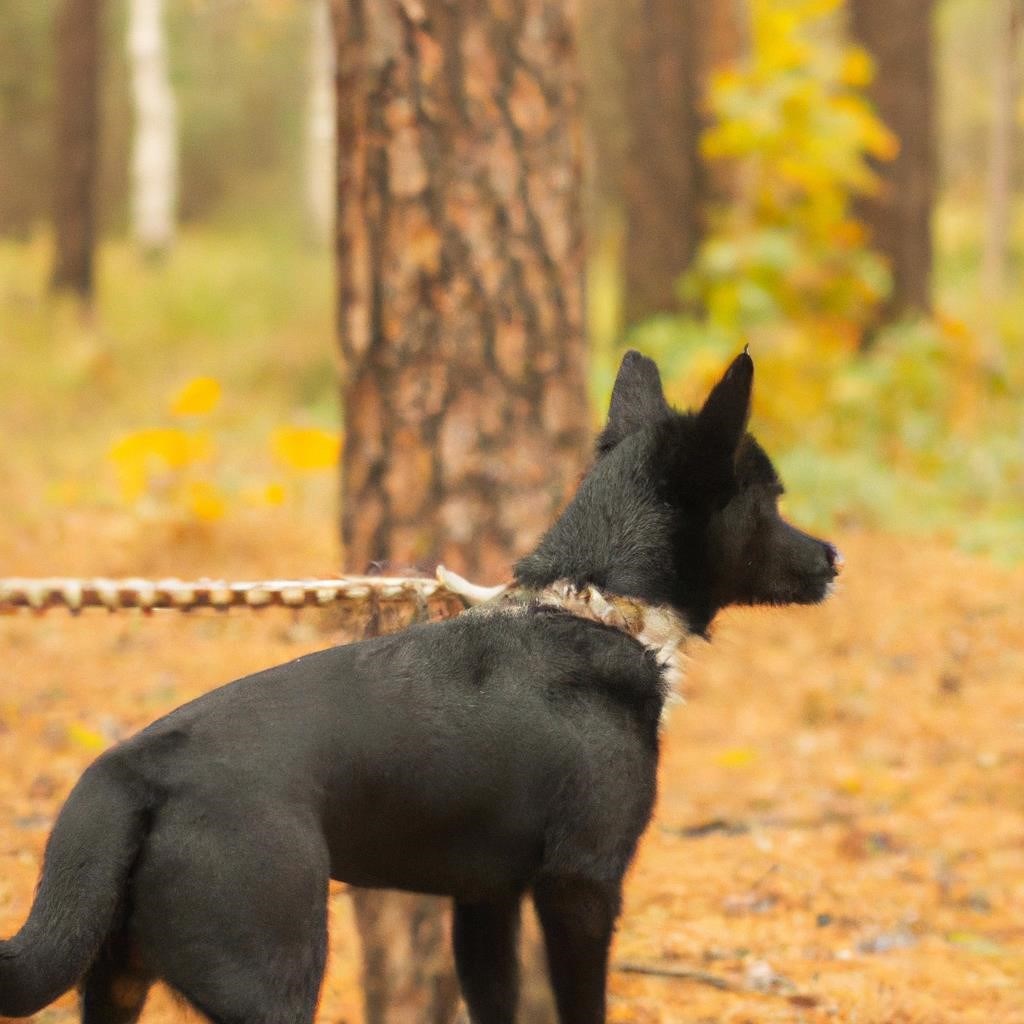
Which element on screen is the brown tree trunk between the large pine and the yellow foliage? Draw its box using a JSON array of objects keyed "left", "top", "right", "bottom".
[{"left": 623, "top": 0, "right": 741, "bottom": 326}]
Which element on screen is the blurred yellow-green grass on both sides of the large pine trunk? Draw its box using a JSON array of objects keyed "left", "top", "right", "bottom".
[{"left": 0, "top": 215, "right": 1024, "bottom": 562}]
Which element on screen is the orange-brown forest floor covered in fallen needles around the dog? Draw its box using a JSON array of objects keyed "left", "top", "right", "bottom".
[{"left": 0, "top": 530, "right": 1024, "bottom": 1024}]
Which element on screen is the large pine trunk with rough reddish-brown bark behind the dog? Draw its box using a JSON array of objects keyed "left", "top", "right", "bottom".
[{"left": 334, "top": 0, "right": 590, "bottom": 1024}]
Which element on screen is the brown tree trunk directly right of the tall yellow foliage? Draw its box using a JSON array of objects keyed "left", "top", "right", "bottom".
[{"left": 850, "top": 0, "right": 936, "bottom": 319}]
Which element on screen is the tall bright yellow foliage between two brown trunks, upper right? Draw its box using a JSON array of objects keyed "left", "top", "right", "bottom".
[{"left": 683, "top": 0, "right": 899, "bottom": 335}]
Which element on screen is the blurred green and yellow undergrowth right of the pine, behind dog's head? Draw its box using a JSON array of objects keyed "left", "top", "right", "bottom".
[{"left": 590, "top": 201, "right": 1024, "bottom": 563}]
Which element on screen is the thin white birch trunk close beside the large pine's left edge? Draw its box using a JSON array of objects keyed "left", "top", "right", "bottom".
[{"left": 306, "top": 0, "right": 336, "bottom": 243}]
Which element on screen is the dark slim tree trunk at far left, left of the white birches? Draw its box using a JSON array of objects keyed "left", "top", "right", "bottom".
[{"left": 50, "top": 0, "right": 102, "bottom": 301}]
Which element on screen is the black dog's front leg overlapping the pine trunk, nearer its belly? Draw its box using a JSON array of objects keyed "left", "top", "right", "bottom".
[{"left": 453, "top": 898, "right": 519, "bottom": 1024}]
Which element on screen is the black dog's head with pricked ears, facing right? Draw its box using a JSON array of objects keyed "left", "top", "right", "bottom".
[{"left": 516, "top": 352, "right": 842, "bottom": 631}]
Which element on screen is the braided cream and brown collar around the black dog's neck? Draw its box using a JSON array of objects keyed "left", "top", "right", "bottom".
[{"left": 437, "top": 566, "right": 694, "bottom": 717}]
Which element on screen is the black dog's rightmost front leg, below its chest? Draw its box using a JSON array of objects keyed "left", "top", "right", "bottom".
[{"left": 534, "top": 879, "right": 622, "bottom": 1024}]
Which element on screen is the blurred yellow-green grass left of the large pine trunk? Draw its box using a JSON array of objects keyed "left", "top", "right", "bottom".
[{"left": 0, "top": 228, "right": 338, "bottom": 512}]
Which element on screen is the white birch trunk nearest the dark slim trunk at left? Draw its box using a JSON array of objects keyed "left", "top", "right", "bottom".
[{"left": 128, "top": 0, "right": 178, "bottom": 255}]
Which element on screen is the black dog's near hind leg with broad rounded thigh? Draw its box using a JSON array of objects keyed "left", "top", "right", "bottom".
[{"left": 132, "top": 794, "right": 329, "bottom": 1024}]
